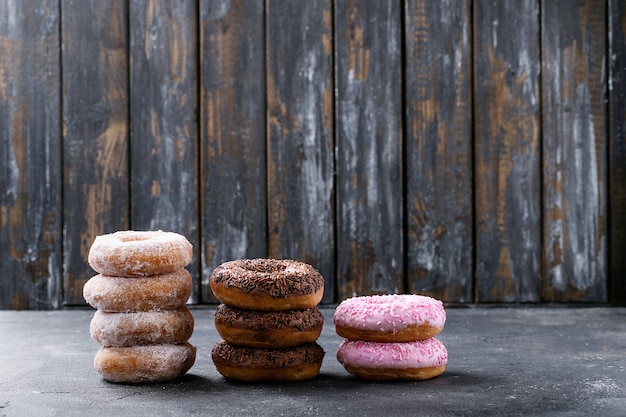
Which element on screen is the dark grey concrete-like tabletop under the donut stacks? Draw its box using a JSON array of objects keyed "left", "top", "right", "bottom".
[{"left": 0, "top": 307, "right": 626, "bottom": 417}]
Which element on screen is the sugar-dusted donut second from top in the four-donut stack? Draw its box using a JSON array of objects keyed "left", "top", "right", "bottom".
[{"left": 83, "top": 268, "right": 193, "bottom": 313}]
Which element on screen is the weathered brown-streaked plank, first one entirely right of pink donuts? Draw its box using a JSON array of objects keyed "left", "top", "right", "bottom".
[{"left": 474, "top": 0, "right": 540, "bottom": 302}]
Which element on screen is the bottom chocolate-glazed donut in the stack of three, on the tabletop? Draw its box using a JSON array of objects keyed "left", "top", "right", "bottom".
[{"left": 211, "top": 340, "right": 324, "bottom": 382}]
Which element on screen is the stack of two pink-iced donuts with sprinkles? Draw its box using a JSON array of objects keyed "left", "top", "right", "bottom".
[{"left": 334, "top": 294, "right": 448, "bottom": 380}]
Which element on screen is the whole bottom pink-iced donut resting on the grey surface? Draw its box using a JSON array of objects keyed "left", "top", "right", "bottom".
[{"left": 337, "top": 338, "right": 448, "bottom": 380}]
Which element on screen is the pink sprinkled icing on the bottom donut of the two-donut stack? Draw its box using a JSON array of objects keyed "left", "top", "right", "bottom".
[{"left": 337, "top": 337, "right": 448, "bottom": 369}]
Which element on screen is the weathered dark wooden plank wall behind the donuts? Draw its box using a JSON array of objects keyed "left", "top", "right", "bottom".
[{"left": 0, "top": 0, "right": 626, "bottom": 309}]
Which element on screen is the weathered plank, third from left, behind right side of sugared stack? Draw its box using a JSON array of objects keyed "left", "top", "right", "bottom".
[{"left": 130, "top": 0, "right": 200, "bottom": 303}]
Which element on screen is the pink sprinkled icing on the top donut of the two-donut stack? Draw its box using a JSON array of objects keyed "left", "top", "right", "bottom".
[{"left": 334, "top": 294, "right": 446, "bottom": 332}]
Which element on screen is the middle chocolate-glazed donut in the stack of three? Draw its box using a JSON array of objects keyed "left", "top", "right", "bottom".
[{"left": 215, "top": 304, "right": 324, "bottom": 348}]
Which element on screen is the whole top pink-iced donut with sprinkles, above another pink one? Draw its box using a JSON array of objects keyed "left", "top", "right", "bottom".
[{"left": 333, "top": 294, "right": 446, "bottom": 342}]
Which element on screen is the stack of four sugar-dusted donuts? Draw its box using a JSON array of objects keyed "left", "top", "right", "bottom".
[{"left": 83, "top": 231, "right": 196, "bottom": 383}]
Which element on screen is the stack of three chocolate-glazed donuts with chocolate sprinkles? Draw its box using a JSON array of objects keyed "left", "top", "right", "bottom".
[{"left": 209, "top": 259, "right": 324, "bottom": 382}]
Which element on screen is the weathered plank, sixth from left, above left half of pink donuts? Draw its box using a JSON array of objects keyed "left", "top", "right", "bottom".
[{"left": 335, "top": 0, "right": 404, "bottom": 300}]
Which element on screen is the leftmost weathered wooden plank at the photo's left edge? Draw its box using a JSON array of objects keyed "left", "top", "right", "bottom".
[{"left": 0, "top": 0, "right": 63, "bottom": 310}]
